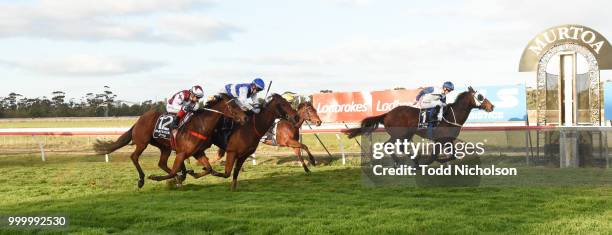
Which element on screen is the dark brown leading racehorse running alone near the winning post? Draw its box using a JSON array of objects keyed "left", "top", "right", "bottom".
[{"left": 343, "top": 87, "right": 494, "bottom": 167}]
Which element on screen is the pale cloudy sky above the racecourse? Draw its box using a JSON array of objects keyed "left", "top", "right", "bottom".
[{"left": 0, "top": 0, "right": 612, "bottom": 102}]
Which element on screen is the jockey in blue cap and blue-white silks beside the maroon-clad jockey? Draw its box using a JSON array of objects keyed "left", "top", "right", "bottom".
[{"left": 221, "top": 78, "right": 266, "bottom": 113}]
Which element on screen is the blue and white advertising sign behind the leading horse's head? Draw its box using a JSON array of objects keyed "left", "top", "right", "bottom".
[{"left": 448, "top": 84, "right": 527, "bottom": 122}]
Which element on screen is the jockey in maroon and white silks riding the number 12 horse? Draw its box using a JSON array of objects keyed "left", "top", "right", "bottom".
[{"left": 166, "top": 85, "right": 204, "bottom": 137}]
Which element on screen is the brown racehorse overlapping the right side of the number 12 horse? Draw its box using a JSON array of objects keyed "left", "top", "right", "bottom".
[{"left": 210, "top": 94, "right": 297, "bottom": 190}]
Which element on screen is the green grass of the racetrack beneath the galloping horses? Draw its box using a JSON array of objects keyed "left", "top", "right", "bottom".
[{"left": 0, "top": 155, "right": 612, "bottom": 234}]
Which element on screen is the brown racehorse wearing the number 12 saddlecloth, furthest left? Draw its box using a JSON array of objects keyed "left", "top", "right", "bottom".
[{"left": 94, "top": 94, "right": 247, "bottom": 188}]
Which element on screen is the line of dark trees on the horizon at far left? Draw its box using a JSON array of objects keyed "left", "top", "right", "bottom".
[{"left": 0, "top": 86, "right": 165, "bottom": 118}]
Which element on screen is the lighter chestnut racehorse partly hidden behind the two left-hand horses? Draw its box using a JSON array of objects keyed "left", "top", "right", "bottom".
[{"left": 213, "top": 102, "right": 321, "bottom": 173}]
